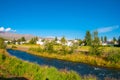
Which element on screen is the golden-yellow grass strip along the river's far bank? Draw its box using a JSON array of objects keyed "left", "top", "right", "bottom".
[{"left": 9, "top": 46, "right": 120, "bottom": 69}]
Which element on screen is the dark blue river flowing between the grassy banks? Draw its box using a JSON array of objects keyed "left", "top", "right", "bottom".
[{"left": 7, "top": 49, "right": 120, "bottom": 80}]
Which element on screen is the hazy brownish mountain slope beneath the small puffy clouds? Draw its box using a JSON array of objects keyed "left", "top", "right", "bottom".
[{"left": 0, "top": 32, "right": 35, "bottom": 40}]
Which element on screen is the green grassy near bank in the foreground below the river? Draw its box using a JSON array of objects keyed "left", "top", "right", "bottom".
[{"left": 0, "top": 49, "right": 96, "bottom": 80}]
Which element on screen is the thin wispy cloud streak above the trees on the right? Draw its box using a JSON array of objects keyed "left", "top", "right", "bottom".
[{"left": 97, "top": 25, "right": 119, "bottom": 33}]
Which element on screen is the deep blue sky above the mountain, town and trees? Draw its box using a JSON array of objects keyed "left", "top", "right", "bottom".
[{"left": 0, "top": 0, "right": 120, "bottom": 39}]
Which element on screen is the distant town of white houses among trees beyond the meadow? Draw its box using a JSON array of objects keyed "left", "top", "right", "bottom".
[{"left": 5, "top": 33, "right": 120, "bottom": 46}]
